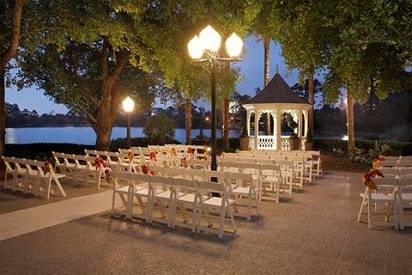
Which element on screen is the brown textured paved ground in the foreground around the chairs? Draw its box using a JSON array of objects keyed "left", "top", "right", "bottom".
[{"left": 0, "top": 172, "right": 412, "bottom": 275}]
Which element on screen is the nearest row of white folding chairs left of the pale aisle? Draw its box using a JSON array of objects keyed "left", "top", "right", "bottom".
[{"left": 2, "top": 156, "right": 66, "bottom": 199}]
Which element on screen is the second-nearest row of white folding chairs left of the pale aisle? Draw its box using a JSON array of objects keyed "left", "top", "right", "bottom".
[{"left": 52, "top": 152, "right": 108, "bottom": 190}]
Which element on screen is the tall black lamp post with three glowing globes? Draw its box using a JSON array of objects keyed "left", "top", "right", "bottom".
[{"left": 187, "top": 25, "right": 243, "bottom": 171}]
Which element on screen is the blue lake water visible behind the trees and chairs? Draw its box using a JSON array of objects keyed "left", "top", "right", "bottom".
[{"left": 6, "top": 127, "right": 240, "bottom": 145}]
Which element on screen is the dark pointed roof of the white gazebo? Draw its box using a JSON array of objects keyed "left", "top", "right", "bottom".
[{"left": 247, "top": 73, "right": 309, "bottom": 104}]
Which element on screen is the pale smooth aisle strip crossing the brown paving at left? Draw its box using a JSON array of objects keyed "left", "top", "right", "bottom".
[{"left": 0, "top": 190, "right": 116, "bottom": 241}]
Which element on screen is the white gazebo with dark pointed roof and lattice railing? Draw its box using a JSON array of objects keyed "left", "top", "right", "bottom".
[{"left": 243, "top": 73, "right": 311, "bottom": 150}]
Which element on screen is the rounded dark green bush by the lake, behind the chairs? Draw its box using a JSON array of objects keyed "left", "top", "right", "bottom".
[{"left": 143, "top": 114, "right": 176, "bottom": 144}]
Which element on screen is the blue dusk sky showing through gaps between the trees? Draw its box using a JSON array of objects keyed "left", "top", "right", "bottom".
[{"left": 6, "top": 36, "right": 298, "bottom": 114}]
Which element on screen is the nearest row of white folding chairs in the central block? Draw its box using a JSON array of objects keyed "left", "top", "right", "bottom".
[{"left": 112, "top": 172, "right": 236, "bottom": 237}]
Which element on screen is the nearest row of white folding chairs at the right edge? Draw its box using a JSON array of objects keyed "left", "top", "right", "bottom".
[{"left": 358, "top": 176, "right": 412, "bottom": 229}]
